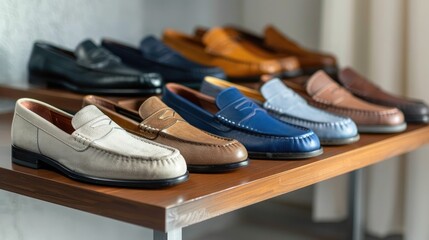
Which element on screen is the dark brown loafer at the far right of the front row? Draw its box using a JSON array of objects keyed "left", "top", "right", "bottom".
[{"left": 337, "top": 68, "right": 429, "bottom": 123}]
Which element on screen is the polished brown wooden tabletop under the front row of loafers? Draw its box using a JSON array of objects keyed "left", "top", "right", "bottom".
[{"left": 0, "top": 111, "right": 429, "bottom": 231}]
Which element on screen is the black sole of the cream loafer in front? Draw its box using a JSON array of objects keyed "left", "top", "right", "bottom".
[{"left": 12, "top": 146, "right": 189, "bottom": 189}]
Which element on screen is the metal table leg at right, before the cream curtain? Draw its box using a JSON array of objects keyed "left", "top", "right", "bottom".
[{"left": 349, "top": 169, "right": 365, "bottom": 240}]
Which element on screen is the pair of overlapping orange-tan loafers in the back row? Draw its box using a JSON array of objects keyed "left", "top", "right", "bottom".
[{"left": 162, "top": 28, "right": 301, "bottom": 81}]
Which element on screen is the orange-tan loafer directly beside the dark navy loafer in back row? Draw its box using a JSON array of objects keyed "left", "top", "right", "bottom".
[{"left": 162, "top": 29, "right": 282, "bottom": 78}]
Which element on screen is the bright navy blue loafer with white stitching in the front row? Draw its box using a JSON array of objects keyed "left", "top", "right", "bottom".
[{"left": 163, "top": 83, "right": 323, "bottom": 159}]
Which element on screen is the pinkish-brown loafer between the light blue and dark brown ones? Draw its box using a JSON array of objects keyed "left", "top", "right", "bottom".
[{"left": 284, "top": 70, "right": 407, "bottom": 133}]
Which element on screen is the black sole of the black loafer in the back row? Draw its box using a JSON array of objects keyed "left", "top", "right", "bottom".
[{"left": 28, "top": 73, "right": 162, "bottom": 95}]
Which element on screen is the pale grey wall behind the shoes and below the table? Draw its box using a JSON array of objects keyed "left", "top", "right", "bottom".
[{"left": 0, "top": 0, "right": 320, "bottom": 240}]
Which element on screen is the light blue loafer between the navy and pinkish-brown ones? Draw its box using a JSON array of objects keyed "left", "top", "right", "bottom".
[{"left": 201, "top": 77, "right": 358, "bottom": 142}]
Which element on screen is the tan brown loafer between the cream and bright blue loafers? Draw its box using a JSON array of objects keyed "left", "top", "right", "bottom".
[{"left": 84, "top": 96, "right": 248, "bottom": 172}]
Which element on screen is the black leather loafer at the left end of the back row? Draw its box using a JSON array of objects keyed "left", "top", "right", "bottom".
[{"left": 28, "top": 40, "right": 163, "bottom": 95}]
